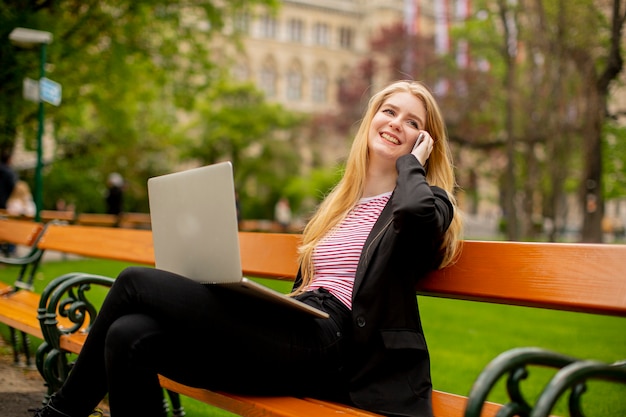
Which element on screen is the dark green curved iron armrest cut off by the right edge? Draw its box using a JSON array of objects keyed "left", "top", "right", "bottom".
[{"left": 531, "top": 361, "right": 626, "bottom": 417}]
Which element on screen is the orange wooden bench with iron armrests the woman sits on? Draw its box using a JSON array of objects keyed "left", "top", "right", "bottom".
[{"left": 0, "top": 219, "right": 626, "bottom": 416}]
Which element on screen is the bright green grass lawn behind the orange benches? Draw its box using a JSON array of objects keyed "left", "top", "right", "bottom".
[{"left": 0, "top": 260, "right": 626, "bottom": 417}]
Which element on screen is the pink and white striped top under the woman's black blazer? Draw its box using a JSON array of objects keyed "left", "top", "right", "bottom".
[{"left": 308, "top": 192, "right": 391, "bottom": 309}]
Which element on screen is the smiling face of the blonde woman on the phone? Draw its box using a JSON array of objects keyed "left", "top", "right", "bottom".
[{"left": 368, "top": 92, "right": 426, "bottom": 166}]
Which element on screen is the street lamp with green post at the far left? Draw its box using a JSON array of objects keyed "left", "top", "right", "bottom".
[{"left": 9, "top": 28, "right": 52, "bottom": 221}]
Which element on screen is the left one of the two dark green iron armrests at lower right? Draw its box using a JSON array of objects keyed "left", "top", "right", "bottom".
[{"left": 465, "top": 347, "right": 578, "bottom": 417}]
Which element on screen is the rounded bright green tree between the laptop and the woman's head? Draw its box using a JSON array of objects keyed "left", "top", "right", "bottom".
[{"left": 183, "top": 80, "right": 304, "bottom": 219}]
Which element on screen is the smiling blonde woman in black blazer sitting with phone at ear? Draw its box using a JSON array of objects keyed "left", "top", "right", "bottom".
[{"left": 35, "top": 81, "right": 461, "bottom": 417}]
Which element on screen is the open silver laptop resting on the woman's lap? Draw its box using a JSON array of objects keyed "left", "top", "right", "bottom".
[{"left": 148, "top": 162, "right": 328, "bottom": 318}]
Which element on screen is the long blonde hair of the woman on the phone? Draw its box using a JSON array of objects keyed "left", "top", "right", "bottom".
[{"left": 295, "top": 81, "right": 462, "bottom": 293}]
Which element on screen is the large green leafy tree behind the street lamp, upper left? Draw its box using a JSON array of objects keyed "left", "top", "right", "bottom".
[{"left": 0, "top": 0, "right": 278, "bottom": 210}]
